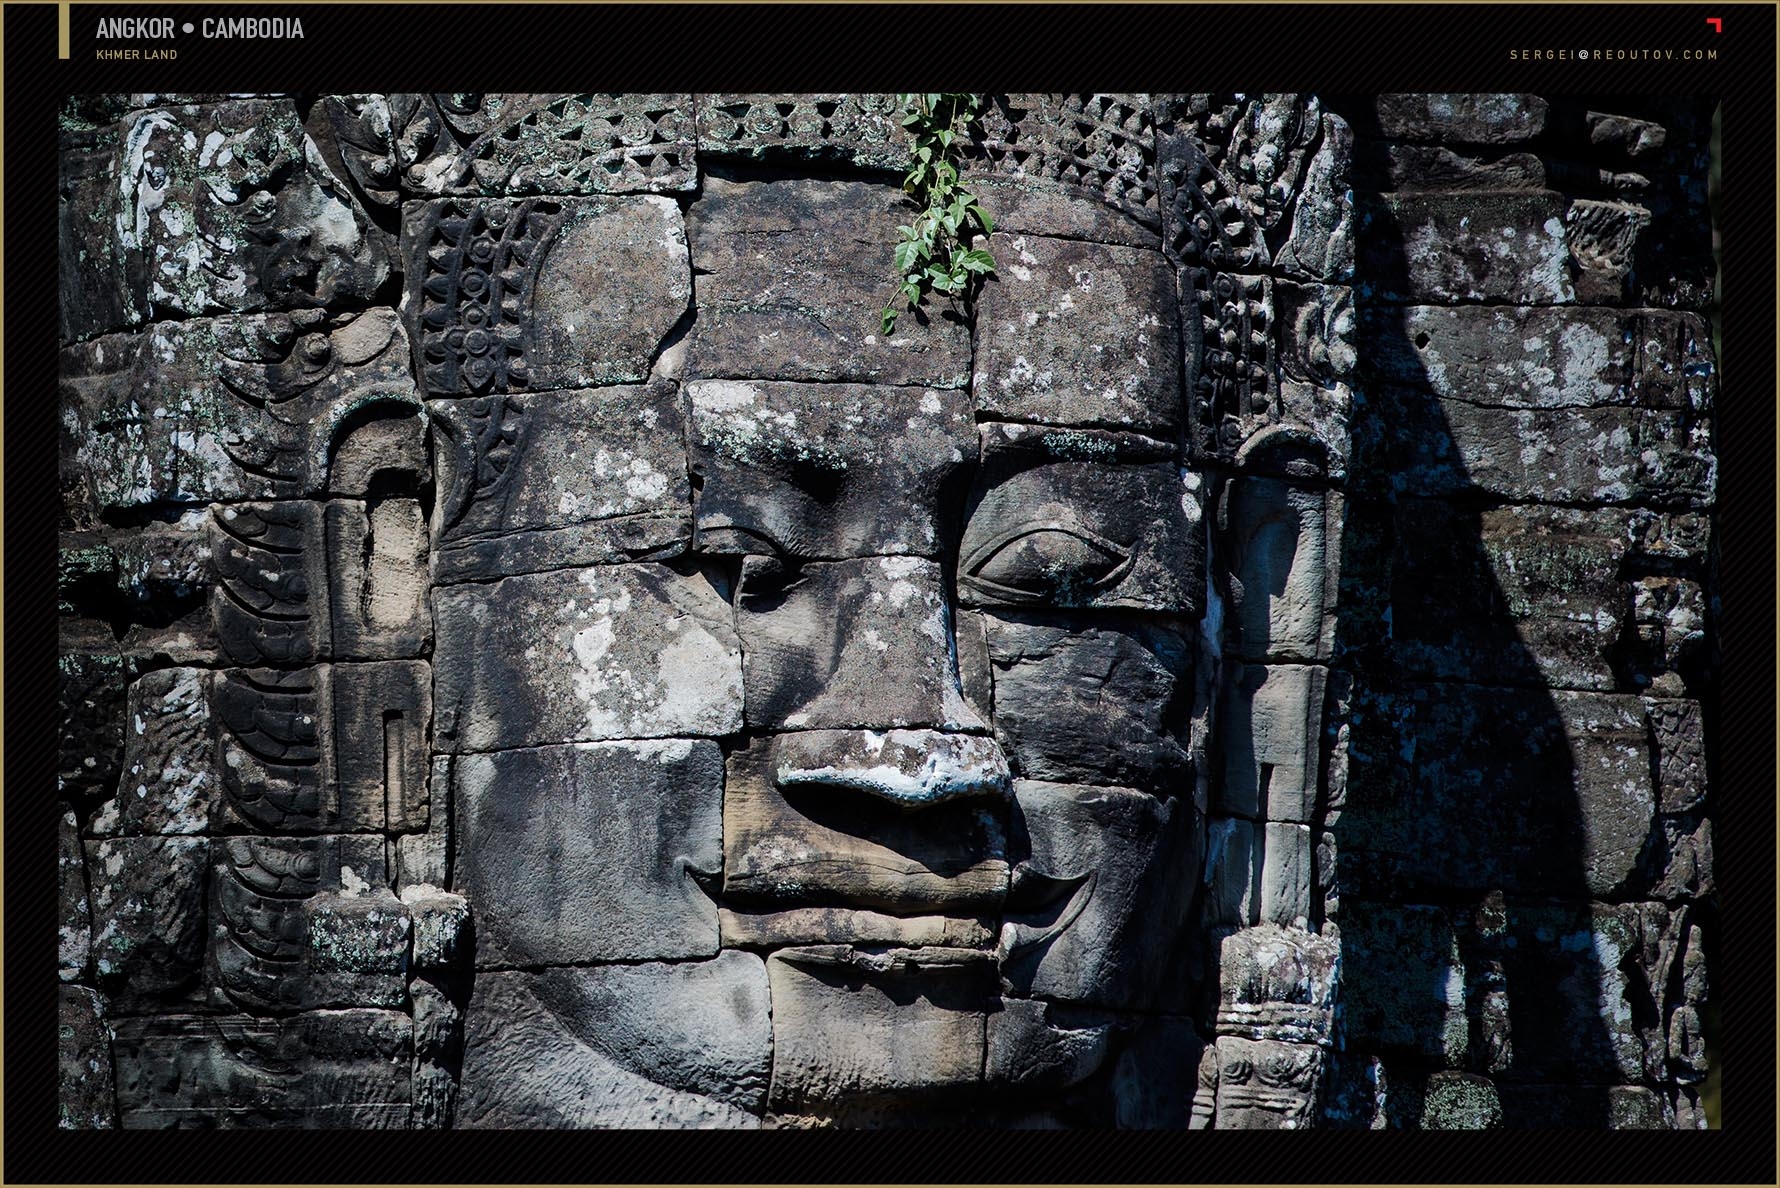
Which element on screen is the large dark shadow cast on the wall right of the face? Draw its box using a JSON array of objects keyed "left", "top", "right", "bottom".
[{"left": 1326, "top": 97, "right": 1668, "bottom": 1129}]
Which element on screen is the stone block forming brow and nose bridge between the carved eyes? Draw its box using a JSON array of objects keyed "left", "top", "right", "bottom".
[{"left": 687, "top": 379, "right": 977, "bottom": 557}]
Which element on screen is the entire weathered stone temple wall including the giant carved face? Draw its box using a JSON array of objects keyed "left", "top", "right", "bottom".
[{"left": 59, "top": 94, "right": 1716, "bottom": 1129}]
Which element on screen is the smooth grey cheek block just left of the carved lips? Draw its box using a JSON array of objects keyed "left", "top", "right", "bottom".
[{"left": 452, "top": 739, "right": 723, "bottom": 965}]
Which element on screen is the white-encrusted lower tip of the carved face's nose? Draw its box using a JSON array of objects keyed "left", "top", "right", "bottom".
[{"left": 773, "top": 730, "right": 1013, "bottom": 809}]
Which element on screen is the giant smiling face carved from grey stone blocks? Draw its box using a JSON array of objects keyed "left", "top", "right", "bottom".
[{"left": 418, "top": 164, "right": 1210, "bottom": 1126}]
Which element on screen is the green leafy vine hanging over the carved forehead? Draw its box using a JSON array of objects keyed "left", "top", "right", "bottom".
[{"left": 883, "top": 94, "right": 995, "bottom": 335}]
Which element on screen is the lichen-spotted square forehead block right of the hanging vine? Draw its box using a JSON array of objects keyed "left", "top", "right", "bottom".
[{"left": 974, "top": 233, "right": 1182, "bottom": 438}]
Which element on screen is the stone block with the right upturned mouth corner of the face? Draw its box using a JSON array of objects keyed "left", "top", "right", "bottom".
[{"left": 1000, "top": 780, "right": 1202, "bottom": 1010}]
